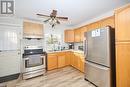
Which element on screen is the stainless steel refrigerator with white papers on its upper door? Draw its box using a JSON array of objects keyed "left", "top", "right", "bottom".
[{"left": 84, "top": 27, "right": 116, "bottom": 87}]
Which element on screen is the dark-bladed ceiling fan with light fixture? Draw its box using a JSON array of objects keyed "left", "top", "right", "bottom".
[{"left": 36, "top": 10, "right": 68, "bottom": 28}]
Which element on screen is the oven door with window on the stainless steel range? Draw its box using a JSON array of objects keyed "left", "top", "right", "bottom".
[{"left": 24, "top": 54, "right": 46, "bottom": 72}]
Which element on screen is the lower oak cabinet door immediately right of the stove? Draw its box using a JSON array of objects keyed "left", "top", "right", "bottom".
[{"left": 47, "top": 54, "right": 58, "bottom": 70}]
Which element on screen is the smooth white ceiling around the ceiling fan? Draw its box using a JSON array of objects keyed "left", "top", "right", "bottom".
[{"left": 15, "top": 0, "right": 130, "bottom": 26}]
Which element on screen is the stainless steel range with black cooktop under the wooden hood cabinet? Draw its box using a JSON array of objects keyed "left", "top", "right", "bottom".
[{"left": 23, "top": 46, "right": 46, "bottom": 79}]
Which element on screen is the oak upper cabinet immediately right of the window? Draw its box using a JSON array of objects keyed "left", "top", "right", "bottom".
[{"left": 64, "top": 30, "right": 74, "bottom": 42}]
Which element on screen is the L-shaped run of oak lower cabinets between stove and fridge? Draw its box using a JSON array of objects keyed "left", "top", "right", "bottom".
[{"left": 47, "top": 51, "right": 84, "bottom": 72}]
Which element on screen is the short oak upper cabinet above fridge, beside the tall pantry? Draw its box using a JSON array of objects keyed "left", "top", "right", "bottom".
[{"left": 100, "top": 16, "right": 115, "bottom": 28}]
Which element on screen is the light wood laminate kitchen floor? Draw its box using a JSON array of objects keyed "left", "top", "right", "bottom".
[{"left": 6, "top": 67, "right": 95, "bottom": 87}]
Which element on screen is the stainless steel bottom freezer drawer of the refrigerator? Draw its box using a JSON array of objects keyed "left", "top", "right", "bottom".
[{"left": 85, "top": 62, "right": 111, "bottom": 87}]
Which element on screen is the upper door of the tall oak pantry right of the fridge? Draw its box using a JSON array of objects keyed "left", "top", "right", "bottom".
[{"left": 115, "top": 5, "right": 130, "bottom": 41}]
